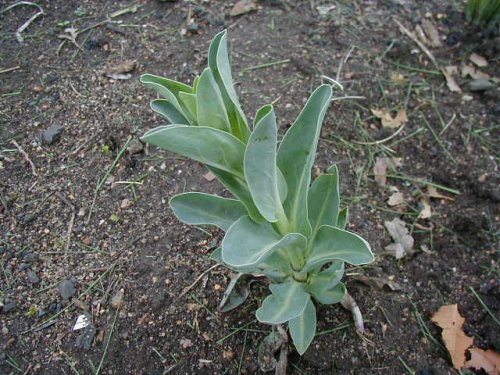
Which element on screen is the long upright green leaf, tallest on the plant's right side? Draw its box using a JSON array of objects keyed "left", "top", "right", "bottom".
[{"left": 278, "top": 85, "right": 332, "bottom": 237}]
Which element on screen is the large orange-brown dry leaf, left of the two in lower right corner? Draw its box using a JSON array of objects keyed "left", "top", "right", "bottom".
[{"left": 431, "top": 304, "right": 473, "bottom": 370}]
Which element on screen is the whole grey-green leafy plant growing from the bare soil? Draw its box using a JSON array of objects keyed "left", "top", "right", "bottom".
[{"left": 141, "top": 31, "right": 373, "bottom": 354}]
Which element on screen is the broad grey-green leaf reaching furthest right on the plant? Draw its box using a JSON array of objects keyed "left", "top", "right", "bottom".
[{"left": 302, "top": 225, "right": 373, "bottom": 272}]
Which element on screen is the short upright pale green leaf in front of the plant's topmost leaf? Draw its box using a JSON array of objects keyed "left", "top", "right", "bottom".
[{"left": 196, "top": 68, "right": 231, "bottom": 133}]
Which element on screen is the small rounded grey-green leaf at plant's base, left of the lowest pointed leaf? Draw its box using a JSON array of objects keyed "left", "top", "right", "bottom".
[{"left": 255, "top": 280, "right": 311, "bottom": 324}]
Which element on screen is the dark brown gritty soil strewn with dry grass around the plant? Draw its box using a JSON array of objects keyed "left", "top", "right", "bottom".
[{"left": 0, "top": 0, "right": 500, "bottom": 375}]
